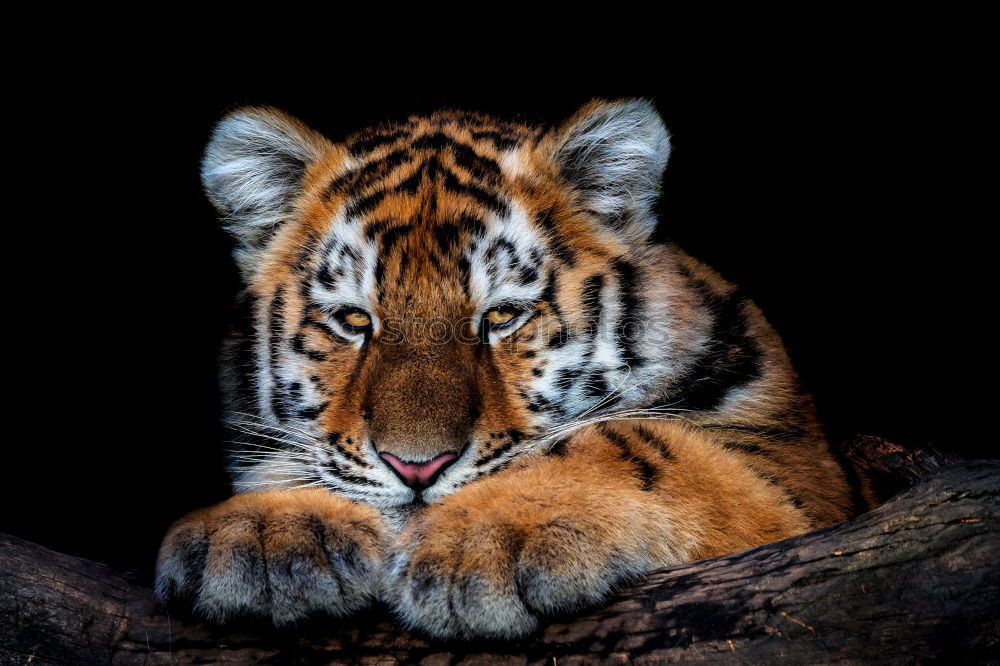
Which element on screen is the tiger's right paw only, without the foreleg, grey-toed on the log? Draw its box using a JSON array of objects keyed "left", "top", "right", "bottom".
[{"left": 386, "top": 500, "right": 651, "bottom": 638}]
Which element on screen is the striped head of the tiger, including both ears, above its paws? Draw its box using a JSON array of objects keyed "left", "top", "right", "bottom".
[{"left": 202, "top": 101, "right": 694, "bottom": 511}]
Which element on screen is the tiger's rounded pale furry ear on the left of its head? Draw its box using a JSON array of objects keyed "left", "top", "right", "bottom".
[{"left": 201, "top": 107, "right": 332, "bottom": 249}]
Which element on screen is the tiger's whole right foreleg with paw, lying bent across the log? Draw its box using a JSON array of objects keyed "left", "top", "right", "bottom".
[{"left": 386, "top": 425, "right": 809, "bottom": 638}]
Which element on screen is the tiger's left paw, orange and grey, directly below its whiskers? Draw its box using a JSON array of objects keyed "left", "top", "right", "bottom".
[{"left": 156, "top": 489, "right": 386, "bottom": 625}]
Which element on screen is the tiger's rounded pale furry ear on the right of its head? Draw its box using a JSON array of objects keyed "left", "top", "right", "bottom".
[{"left": 551, "top": 99, "right": 670, "bottom": 243}]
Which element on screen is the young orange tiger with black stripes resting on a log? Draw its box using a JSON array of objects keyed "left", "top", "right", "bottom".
[{"left": 155, "top": 99, "right": 864, "bottom": 639}]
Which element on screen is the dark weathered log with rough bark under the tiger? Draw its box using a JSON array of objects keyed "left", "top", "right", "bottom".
[{"left": 0, "top": 439, "right": 1000, "bottom": 666}]
